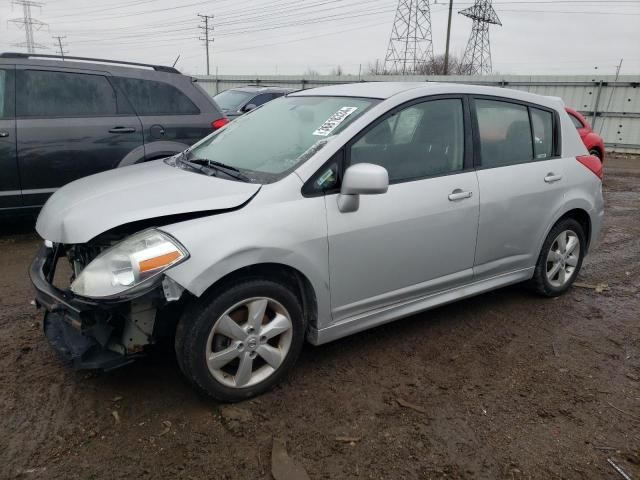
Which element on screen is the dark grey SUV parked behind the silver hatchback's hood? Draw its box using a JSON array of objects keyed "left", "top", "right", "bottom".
[{"left": 0, "top": 53, "right": 228, "bottom": 213}]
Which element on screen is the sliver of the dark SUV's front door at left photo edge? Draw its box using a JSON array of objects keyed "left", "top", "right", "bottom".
[{"left": 0, "top": 65, "right": 22, "bottom": 210}]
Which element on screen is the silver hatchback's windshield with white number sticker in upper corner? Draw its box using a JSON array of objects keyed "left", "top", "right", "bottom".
[{"left": 187, "top": 96, "right": 379, "bottom": 183}]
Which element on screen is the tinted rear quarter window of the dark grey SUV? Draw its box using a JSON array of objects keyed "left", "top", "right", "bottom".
[{"left": 112, "top": 77, "right": 200, "bottom": 115}]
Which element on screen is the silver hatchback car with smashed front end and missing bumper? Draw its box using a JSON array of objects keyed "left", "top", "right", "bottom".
[{"left": 30, "top": 83, "right": 603, "bottom": 401}]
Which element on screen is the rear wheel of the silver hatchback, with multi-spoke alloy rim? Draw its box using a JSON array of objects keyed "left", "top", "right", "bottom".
[{"left": 531, "top": 218, "right": 586, "bottom": 297}]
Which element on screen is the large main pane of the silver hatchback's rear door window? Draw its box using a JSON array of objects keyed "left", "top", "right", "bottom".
[{"left": 475, "top": 99, "right": 533, "bottom": 167}]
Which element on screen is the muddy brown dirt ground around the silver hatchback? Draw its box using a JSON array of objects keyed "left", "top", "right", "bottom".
[{"left": 0, "top": 157, "right": 640, "bottom": 480}]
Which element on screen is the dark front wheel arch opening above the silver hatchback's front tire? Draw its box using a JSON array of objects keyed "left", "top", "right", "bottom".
[{"left": 194, "top": 262, "right": 318, "bottom": 334}]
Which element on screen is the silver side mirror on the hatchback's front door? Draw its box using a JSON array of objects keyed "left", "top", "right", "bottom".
[{"left": 338, "top": 163, "right": 389, "bottom": 213}]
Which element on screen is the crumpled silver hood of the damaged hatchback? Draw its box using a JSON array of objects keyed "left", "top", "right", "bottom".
[{"left": 36, "top": 160, "right": 260, "bottom": 243}]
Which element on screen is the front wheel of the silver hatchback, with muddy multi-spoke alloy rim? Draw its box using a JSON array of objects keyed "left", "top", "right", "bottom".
[{"left": 176, "top": 280, "right": 305, "bottom": 402}]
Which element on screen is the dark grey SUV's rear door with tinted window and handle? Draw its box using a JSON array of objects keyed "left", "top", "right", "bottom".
[{"left": 16, "top": 66, "right": 142, "bottom": 206}]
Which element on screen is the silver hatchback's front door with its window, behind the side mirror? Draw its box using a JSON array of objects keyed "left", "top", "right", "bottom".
[{"left": 320, "top": 97, "right": 479, "bottom": 321}]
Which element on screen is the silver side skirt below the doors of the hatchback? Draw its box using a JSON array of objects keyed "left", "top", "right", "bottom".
[{"left": 307, "top": 267, "right": 534, "bottom": 345}]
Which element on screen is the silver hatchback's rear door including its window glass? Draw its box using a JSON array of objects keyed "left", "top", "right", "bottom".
[{"left": 473, "top": 97, "right": 566, "bottom": 279}]
